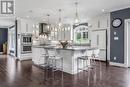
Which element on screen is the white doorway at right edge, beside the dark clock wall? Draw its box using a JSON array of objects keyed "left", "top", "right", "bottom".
[{"left": 124, "top": 19, "right": 130, "bottom": 67}]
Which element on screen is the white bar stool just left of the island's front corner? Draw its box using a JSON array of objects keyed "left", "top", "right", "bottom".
[{"left": 47, "top": 49, "right": 63, "bottom": 71}]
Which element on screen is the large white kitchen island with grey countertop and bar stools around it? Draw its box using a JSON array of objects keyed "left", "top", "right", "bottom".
[{"left": 32, "top": 45, "right": 91, "bottom": 74}]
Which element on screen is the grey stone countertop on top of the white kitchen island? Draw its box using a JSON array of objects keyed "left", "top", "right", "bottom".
[{"left": 32, "top": 45, "right": 93, "bottom": 51}]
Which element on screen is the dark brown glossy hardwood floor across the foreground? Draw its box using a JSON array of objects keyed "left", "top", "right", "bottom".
[{"left": 0, "top": 56, "right": 130, "bottom": 87}]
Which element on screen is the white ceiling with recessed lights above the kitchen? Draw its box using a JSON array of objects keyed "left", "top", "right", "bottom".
[{"left": 12, "top": 0, "right": 130, "bottom": 23}]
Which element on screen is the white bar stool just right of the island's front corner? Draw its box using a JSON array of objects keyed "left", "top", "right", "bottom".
[{"left": 77, "top": 49, "right": 93, "bottom": 71}]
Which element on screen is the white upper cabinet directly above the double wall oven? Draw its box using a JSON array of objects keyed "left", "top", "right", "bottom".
[{"left": 17, "top": 19, "right": 34, "bottom": 34}]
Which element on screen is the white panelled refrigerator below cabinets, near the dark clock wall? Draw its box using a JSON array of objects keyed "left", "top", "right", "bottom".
[{"left": 91, "top": 30, "right": 107, "bottom": 61}]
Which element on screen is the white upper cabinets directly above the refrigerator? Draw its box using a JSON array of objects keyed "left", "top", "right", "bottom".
[{"left": 89, "top": 14, "right": 110, "bottom": 30}]
